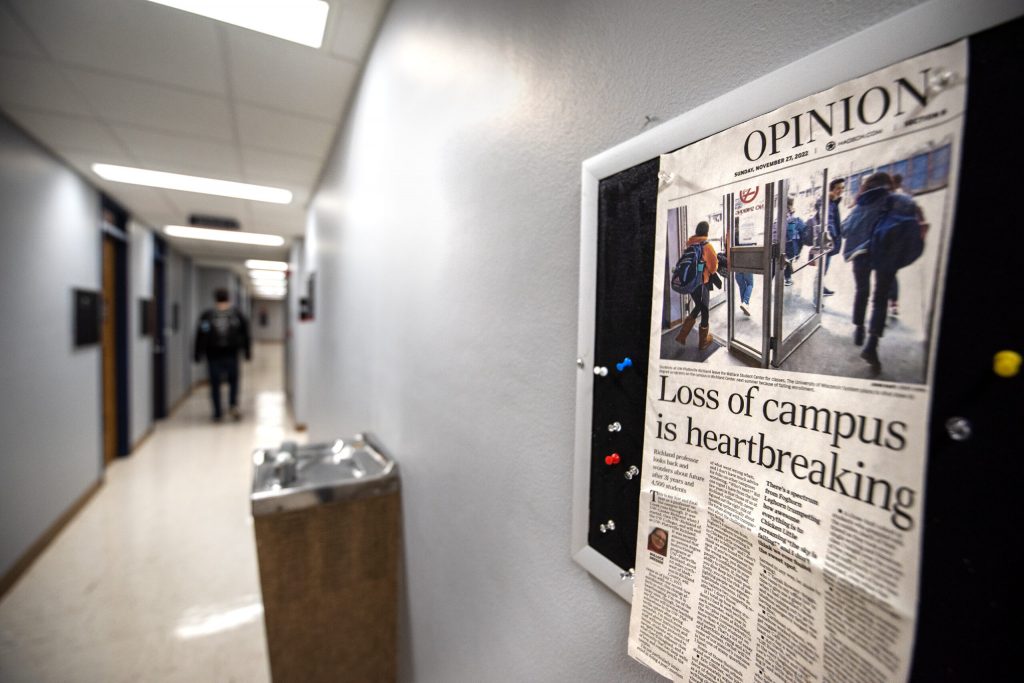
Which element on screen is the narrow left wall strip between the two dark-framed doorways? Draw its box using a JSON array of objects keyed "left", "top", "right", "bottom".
[{"left": 128, "top": 220, "right": 154, "bottom": 447}]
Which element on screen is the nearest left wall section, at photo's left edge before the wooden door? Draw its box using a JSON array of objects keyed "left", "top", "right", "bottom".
[{"left": 0, "top": 116, "right": 102, "bottom": 574}]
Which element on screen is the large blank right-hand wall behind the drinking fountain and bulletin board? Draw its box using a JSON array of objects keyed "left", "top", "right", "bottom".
[{"left": 295, "top": 0, "right": 937, "bottom": 683}]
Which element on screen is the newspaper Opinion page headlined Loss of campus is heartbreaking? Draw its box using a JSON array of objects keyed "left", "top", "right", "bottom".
[{"left": 629, "top": 41, "right": 968, "bottom": 683}]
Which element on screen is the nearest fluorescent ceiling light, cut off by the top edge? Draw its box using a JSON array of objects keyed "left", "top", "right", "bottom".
[{"left": 150, "top": 0, "right": 330, "bottom": 47}]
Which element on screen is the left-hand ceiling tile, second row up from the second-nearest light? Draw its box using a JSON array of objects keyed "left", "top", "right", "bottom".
[{"left": 63, "top": 69, "right": 233, "bottom": 142}]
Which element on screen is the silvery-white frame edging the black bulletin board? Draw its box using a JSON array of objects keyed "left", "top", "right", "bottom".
[{"left": 571, "top": 0, "right": 1024, "bottom": 602}]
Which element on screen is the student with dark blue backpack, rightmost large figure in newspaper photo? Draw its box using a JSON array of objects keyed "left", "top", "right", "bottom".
[{"left": 843, "top": 173, "right": 925, "bottom": 373}]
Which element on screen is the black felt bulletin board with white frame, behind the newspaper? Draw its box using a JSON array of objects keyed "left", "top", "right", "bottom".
[{"left": 572, "top": 2, "right": 1024, "bottom": 681}]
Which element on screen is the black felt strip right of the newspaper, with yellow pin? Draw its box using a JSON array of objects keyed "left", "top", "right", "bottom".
[{"left": 910, "top": 19, "right": 1024, "bottom": 681}]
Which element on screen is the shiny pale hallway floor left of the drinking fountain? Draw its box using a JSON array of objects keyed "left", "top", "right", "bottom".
[{"left": 0, "top": 343, "right": 302, "bottom": 683}]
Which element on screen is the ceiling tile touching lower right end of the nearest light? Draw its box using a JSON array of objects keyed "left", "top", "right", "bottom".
[{"left": 227, "top": 29, "right": 356, "bottom": 121}]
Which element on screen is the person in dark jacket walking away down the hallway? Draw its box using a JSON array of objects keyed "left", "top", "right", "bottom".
[{"left": 194, "top": 289, "right": 252, "bottom": 422}]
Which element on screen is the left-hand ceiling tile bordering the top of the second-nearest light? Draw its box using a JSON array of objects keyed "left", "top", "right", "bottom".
[{"left": 113, "top": 126, "right": 244, "bottom": 180}]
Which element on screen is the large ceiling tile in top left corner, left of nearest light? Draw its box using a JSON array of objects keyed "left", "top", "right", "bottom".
[{"left": 11, "top": 0, "right": 225, "bottom": 93}]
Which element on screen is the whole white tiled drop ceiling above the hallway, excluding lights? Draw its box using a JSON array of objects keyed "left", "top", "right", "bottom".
[{"left": 0, "top": 0, "right": 388, "bottom": 258}]
